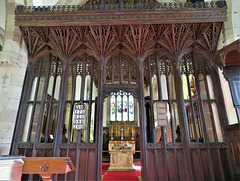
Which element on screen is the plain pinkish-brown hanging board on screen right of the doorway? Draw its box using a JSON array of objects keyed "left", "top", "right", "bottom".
[{"left": 155, "top": 101, "right": 169, "bottom": 127}]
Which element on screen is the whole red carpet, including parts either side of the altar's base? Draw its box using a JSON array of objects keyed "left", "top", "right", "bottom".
[{"left": 102, "top": 164, "right": 141, "bottom": 181}]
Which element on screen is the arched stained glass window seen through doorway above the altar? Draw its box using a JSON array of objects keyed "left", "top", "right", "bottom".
[{"left": 110, "top": 91, "right": 134, "bottom": 121}]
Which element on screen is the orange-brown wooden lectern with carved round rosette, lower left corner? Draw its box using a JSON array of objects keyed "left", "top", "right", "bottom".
[{"left": 22, "top": 157, "right": 75, "bottom": 181}]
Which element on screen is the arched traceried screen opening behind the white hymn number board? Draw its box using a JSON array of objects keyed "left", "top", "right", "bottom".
[{"left": 62, "top": 54, "right": 99, "bottom": 143}]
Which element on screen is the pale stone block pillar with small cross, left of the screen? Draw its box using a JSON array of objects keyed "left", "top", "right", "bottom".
[{"left": 0, "top": 0, "right": 27, "bottom": 155}]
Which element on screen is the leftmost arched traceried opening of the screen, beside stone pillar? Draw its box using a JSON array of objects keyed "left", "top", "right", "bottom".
[{"left": 22, "top": 56, "right": 62, "bottom": 147}]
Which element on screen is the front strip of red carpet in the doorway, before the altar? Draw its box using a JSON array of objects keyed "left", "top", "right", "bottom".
[{"left": 103, "top": 171, "right": 139, "bottom": 181}]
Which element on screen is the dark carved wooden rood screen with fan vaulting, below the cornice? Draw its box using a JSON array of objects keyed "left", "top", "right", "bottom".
[{"left": 12, "top": 18, "right": 232, "bottom": 180}]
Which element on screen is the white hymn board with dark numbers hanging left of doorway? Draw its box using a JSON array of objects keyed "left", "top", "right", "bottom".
[{"left": 73, "top": 103, "right": 85, "bottom": 130}]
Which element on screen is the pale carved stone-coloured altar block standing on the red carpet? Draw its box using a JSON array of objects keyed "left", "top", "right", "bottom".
[{"left": 108, "top": 141, "right": 135, "bottom": 171}]
